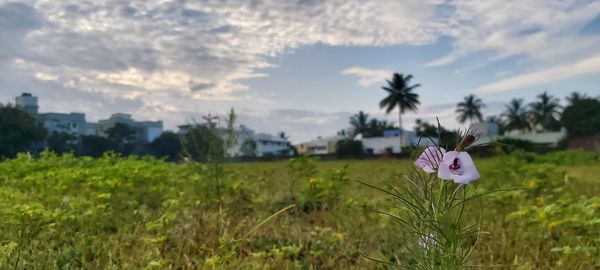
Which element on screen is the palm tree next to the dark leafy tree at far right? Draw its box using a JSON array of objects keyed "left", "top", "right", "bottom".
[{"left": 529, "top": 91, "right": 562, "bottom": 130}]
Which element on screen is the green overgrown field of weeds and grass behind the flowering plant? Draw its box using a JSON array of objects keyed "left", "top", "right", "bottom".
[{"left": 0, "top": 152, "right": 600, "bottom": 269}]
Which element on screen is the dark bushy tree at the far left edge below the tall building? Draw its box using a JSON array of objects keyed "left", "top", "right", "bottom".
[{"left": 0, "top": 104, "right": 46, "bottom": 159}]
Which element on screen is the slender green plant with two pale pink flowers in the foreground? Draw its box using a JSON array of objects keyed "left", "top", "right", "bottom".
[{"left": 361, "top": 127, "right": 481, "bottom": 269}]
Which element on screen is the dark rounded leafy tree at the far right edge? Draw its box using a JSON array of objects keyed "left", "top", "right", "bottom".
[{"left": 562, "top": 98, "right": 600, "bottom": 137}]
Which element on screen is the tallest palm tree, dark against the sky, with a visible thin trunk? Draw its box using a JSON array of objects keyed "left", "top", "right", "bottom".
[{"left": 379, "top": 73, "right": 421, "bottom": 147}]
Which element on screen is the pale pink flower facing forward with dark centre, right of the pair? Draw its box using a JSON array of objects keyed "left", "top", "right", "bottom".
[{"left": 438, "top": 151, "right": 480, "bottom": 184}]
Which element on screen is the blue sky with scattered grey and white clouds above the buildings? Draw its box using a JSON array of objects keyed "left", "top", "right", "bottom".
[{"left": 0, "top": 0, "right": 600, "bottom": 142}]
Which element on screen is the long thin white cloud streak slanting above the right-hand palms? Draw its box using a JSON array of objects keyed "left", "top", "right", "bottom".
[{"left": 478, "top": 55, "right": 600, "bottom": 93}]
